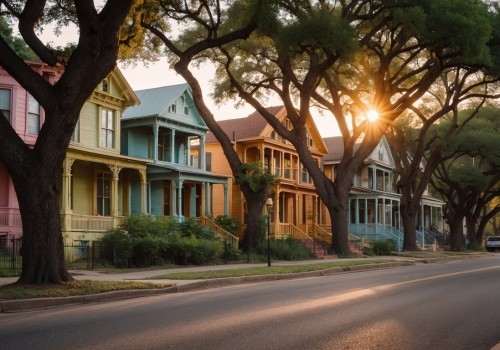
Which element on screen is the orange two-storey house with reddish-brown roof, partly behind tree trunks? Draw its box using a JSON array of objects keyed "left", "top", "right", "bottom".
[{"left": 205, "top": 106, "right": 328, "bottom": 238}]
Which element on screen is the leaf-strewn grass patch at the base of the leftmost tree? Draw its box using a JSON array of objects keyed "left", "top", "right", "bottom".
[{"left": 0, "top": 280, "right": 169, "bottom": 300}]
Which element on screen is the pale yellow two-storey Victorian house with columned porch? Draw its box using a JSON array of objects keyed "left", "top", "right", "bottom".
[{"left": 61, "top": 68, "right": 149, "bottom": 246}]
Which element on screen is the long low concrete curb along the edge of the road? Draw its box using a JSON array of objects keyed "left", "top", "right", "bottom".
[{"left": 0, "top": 259, "right": 414, "bottom": 313}]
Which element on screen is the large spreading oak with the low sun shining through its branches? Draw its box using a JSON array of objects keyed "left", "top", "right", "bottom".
[{"left": 139, "top": 0, "right": 491, "bottom": 254}]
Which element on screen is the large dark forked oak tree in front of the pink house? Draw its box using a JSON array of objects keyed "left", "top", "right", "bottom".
[{"left": 0, "top": 0, "right": 133, "bottom": 283}]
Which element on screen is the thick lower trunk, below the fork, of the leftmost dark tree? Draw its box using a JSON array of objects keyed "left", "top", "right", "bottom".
[{"left": 14, "top": 157, "right": 72, "bottom": 284}]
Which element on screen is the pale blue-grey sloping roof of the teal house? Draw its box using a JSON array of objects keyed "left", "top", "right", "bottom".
[{"left": 122, "top": 83, "right": 190, "bottom": 119}]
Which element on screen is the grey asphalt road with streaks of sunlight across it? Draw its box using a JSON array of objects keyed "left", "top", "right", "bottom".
[{"left": 0, "top": 255, "right": 500, "bottom": 350}]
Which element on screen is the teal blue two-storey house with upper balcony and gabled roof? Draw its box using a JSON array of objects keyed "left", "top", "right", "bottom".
[{"left": 121, "top": 84, "right": 228, "bottom": 221}]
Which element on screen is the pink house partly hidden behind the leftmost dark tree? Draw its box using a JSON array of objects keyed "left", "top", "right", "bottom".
[{"left": 0, "top": 62, "right": 61, "bottom": 247}]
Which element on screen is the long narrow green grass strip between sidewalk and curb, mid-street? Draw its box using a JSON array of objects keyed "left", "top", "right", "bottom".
[{"left": 149, "top": 259, "right": 398, "bottom": 280}]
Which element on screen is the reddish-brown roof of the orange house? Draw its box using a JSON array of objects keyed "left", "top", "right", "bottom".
[{"left": 205, "top": 106, "right": 283, "bottom": 143}]
